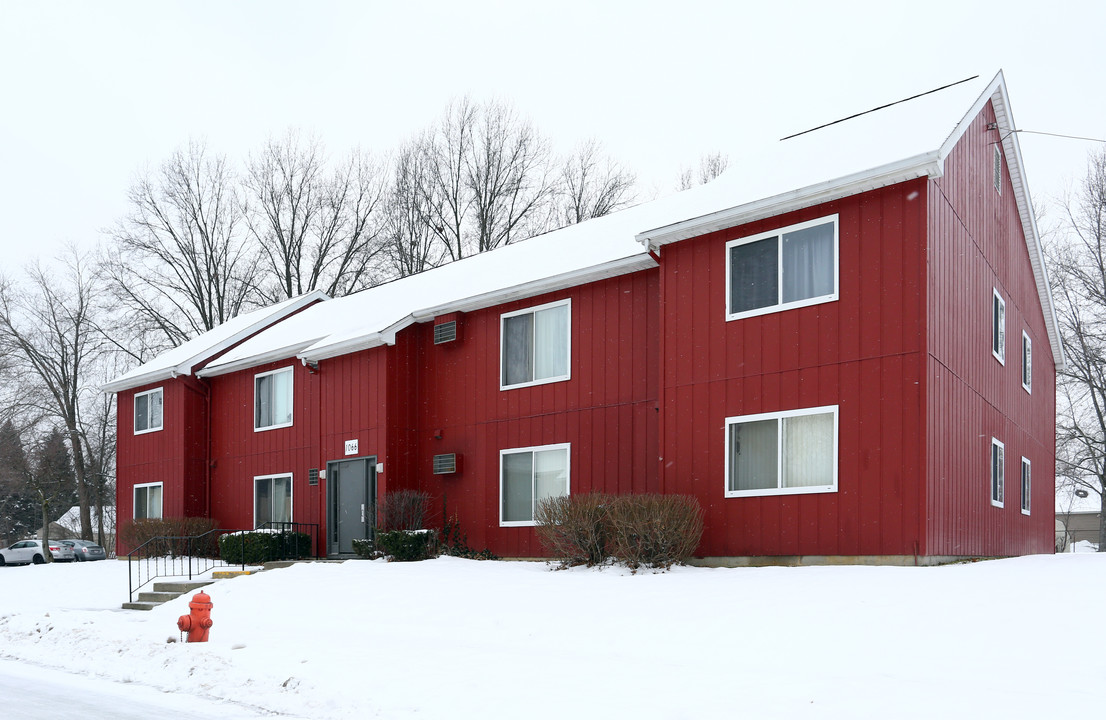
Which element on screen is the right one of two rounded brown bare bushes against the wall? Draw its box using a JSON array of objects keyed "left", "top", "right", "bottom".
[{"left": 606, "top": 493, "right": 702, "bottom": 570}]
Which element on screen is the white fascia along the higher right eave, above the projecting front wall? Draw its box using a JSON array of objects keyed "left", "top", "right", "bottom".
[{"left": 636, "top": 150, "right": 945, "bottom": 251}]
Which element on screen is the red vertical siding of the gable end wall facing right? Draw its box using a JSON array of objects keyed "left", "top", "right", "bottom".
[{"left": 926, "top": 98, "right": 1055, "bottom": 555}]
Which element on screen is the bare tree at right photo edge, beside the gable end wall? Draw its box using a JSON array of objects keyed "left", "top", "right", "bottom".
[{"left": 1048, "top": 150, "right": 1106, "bottom": 552}]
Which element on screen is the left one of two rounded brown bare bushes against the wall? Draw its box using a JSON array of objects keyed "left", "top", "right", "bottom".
[{"left": 534, "top": 493, "right": 615, "bottom": 567}]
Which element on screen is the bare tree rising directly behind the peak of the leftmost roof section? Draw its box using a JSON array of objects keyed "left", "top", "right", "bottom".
[{"left": 243, "top": 132, "right": 382, "bottom": 302}]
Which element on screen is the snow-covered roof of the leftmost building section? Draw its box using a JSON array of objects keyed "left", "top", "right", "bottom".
[{"left": 102, "top": 291, "right": 327, "bottom": 393}]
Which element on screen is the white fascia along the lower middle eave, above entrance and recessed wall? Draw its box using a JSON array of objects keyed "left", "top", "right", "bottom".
[{"left": 296, "top": 252, "right": 657, "bottom": 363}]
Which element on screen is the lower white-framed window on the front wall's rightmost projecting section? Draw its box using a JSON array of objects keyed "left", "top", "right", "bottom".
[{"left": 726, "top": 405, "right": 837, "bottom": 498}]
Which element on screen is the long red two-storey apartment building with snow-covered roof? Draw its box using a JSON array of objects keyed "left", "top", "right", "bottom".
[{"left": 107, "top": 73, "right": 1063, "bottom": 562}]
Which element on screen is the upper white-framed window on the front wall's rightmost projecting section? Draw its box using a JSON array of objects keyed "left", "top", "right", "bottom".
[{"left": 726, "top": 215, "right": 837, "bottom": 320}]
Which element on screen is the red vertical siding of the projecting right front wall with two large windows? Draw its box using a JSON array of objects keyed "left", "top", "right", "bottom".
[{"left": 660, "top": 180, "right": 926, "bottom": 555}]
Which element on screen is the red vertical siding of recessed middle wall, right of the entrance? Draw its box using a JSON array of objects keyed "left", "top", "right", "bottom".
[{"left": 415, "top": 271, "right": 658, "bottom": 556}]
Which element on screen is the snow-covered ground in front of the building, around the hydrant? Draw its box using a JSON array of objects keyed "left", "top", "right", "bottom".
[{"left": 0, "top": 554, "right": 1106, "bottom": 720}]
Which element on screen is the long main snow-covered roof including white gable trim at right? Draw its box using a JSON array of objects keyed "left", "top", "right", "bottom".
[{"left": 131, "top": 72, "right": 1063, "bottom": 376}]
